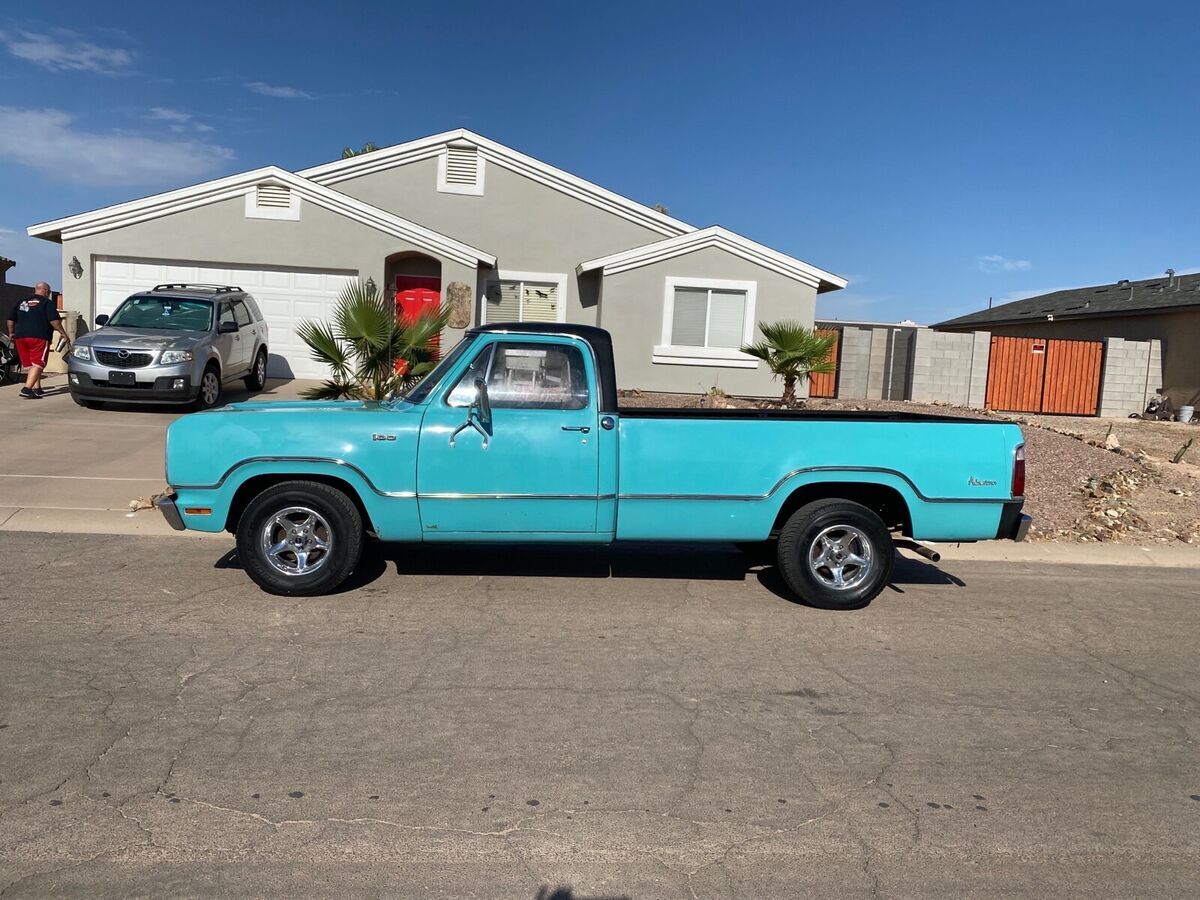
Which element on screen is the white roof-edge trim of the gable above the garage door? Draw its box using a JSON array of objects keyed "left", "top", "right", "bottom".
[{"left": 26, "top": 166, "right": 496, "bottom": 266}]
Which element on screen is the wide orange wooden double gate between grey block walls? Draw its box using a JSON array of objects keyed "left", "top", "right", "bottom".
[{"left": 988, "top": 335, "right": 1104, "bottom": 415}]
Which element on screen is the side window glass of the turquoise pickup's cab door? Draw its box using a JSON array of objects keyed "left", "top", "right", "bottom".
[{"left": 449, "top": 342, "right": 589, "bottom": 409}]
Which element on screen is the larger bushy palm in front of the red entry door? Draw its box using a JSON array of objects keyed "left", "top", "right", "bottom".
[{"left": 296, "top": 281, "right": 450, "bottom": 400}]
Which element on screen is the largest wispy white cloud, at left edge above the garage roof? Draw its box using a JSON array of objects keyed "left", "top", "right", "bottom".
[{"left": 0, "top": 107, "right": 234, "bottom": 186}]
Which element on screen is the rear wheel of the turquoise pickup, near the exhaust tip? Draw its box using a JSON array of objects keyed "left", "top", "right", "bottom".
[{"left": 778, "top": 499, "right": 895, "bottom": 610}]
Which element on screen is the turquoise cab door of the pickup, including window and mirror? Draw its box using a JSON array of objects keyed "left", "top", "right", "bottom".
[{"left": 416, "top": 337, "right": 599, "bottom": 540}]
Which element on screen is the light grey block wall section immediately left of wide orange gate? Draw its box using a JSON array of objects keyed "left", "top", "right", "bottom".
[{"left": 910, "top": 329, "right": 991, "bottom": 409}]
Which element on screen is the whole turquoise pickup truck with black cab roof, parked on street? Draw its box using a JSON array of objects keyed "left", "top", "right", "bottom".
[{"left": 158, "top": 323, "right": 1030, "bottom": 608}]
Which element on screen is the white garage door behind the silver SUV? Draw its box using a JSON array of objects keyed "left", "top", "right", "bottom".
[{"left": 95, "top": 259, "right": 355, "bottom": 378}]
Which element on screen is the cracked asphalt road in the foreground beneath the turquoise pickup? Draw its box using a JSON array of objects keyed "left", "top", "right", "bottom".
[{"left": 0, "top": 533, "right": 1200, "bottom": 900}]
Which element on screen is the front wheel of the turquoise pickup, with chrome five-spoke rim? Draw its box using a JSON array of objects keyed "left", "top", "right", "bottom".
[{"left": 238, "top": 481, "right": 365, "bottom": 596}]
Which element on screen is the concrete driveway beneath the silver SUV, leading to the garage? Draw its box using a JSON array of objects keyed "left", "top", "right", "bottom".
[{"left": 0, "top": 376, "right": 313, "bottom": 534}]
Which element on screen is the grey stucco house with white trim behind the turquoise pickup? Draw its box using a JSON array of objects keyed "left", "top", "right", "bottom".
[{"left": 21, "top": 128, "right": 846, "bottom": 395}]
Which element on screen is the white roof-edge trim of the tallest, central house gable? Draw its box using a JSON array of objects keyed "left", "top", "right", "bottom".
[{"left": 296, "top": 128, "right": 696, "bottom": 235}]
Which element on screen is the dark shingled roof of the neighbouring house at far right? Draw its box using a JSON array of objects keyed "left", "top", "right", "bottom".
[{"left": 934, "top": 274, "right": 1200, "bottom": 336}]
